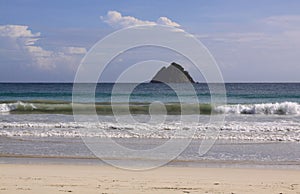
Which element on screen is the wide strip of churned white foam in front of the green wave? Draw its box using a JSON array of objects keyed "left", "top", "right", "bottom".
[{"left": 0, "top": 121, "right": 300, "bottom": 142}]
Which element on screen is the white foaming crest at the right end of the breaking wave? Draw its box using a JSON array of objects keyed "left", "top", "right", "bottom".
[{"left": 214, "top": 102, "right": 300, "bottom": 115}]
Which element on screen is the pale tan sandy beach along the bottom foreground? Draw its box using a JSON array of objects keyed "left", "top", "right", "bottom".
[{"left": 0, "top": 164, "right": 300, "bottom": 194}]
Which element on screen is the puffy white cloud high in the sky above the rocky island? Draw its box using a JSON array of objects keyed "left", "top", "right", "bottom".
[{"left": 100, "top": 11, "right": 180, "bottom": 28}]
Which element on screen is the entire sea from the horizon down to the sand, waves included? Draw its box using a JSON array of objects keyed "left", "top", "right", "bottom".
[{"left": 0, "top": 83, "right": 300, "bottom": 168}]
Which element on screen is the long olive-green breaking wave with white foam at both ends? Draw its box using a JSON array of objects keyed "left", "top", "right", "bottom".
[{"left": 0, "top": 101, "right": 300, "bottom": 115}]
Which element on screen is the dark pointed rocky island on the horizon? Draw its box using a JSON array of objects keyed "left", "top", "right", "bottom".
[{"left": 150, "top": 62, "right": 195, "bottom": 83}]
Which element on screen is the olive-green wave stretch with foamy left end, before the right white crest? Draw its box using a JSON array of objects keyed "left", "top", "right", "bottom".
[{"left": 0, "top": 101, "right": 212, "bottom": 115}]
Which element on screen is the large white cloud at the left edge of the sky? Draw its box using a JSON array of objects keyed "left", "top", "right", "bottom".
[{"left": 0, "top": 25, "right": 86, "bottom": 70}]
